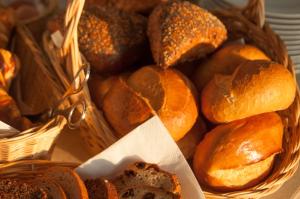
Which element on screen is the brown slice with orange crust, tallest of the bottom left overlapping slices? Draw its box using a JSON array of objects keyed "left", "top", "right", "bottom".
[{"left": 44, "top": 167, "right": 88, "bottom": 199}]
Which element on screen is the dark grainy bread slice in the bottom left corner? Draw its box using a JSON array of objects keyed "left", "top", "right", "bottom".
[{"left": 0, "top": 179, "right": 49, "bottom": 199}]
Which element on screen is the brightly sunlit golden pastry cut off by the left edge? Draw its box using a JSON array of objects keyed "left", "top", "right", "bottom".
[{"left": 0, "top": 48, "right": 20, "bottom": 91}]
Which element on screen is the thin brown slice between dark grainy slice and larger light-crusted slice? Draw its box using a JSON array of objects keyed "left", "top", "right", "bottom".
[{"left": 31, "top": 178, "right": 67, "bottom": 199}]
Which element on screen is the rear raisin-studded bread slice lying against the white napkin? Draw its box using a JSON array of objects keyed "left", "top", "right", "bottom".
[{"left": 113, "top": 162, "right": 181, "bottom": 194}]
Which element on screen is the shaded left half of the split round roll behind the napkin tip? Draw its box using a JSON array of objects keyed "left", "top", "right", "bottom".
[{"left": 103, "top": 78, "right": 154, "bottom": 137}]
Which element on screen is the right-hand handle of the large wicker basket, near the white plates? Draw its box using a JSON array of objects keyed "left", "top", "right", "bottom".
[{"left": 242, "top": 0, "right": 265, "bottom": 28}]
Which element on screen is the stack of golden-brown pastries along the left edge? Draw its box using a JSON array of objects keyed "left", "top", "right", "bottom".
[{"left": 0, "top": 8, "right": 33, "bottom": 132}]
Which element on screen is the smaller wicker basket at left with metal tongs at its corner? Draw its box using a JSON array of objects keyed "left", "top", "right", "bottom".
[{"left": 0, "top": 14, "right": 86, "bottom": 163}]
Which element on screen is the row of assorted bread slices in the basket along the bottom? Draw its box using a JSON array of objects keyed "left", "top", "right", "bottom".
[{"left": 0, "top": 162, "right": 181, "bottom": 199}]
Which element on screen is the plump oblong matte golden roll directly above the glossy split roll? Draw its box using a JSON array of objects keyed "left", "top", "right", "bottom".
[{"left": 201, "top": 60, "right": 296, "bottom": 123}]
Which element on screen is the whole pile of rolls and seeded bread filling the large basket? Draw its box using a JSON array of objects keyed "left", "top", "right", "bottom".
[{"left": 44, "top": 0, "right": 296, "bottom": 193}]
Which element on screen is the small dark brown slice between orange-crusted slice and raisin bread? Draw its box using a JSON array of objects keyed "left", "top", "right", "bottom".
[{"left": 84, "top": 178, "right": 118, "bottom": 199}]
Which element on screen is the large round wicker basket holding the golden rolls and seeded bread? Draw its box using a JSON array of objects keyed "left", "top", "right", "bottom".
[{"left": 44, "top": 0, "right": 300, "bottom": 198}]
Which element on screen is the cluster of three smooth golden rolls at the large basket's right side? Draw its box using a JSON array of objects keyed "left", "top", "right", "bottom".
[{"left": 193, "top": 44, "right": 296, "bottom": 191}]
